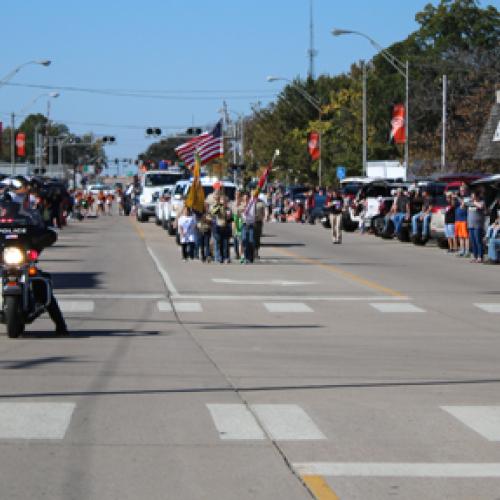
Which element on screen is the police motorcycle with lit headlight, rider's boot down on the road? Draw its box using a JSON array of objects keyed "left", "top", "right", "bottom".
[{"left": 0, "top": 199, "right": 67, "bottom": 338}]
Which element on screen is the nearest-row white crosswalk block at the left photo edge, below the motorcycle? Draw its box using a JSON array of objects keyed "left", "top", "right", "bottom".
[{"left": 0, "top": 403, "right": 75, "bottom": 439}]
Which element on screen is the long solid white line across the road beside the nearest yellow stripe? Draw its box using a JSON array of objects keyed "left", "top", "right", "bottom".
[{"left": 292, "top": 462, "right": 500, "bottom": 478}]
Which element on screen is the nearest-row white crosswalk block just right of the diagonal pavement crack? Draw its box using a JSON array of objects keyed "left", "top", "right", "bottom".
[{"left": 251, "top": 404, "right": 326, "bottom": 441}]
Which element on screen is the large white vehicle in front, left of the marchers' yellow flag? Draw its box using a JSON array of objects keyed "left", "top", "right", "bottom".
[{"left": 137, "top": 170, "right": 184, "bottom": 222}]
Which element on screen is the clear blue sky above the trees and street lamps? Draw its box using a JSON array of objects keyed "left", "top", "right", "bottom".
[{"left": 0, "top": 0, "right": 499, "bottom": 170}]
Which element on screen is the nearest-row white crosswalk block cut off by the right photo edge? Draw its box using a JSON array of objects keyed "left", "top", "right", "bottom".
[{"left": 441, "top": 406, "right": 500, "bottom": 441}]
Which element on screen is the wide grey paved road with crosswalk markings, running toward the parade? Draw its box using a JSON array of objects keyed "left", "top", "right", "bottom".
[{"left": 0, "top": 216, "right": 500, "bottom": 500}]
